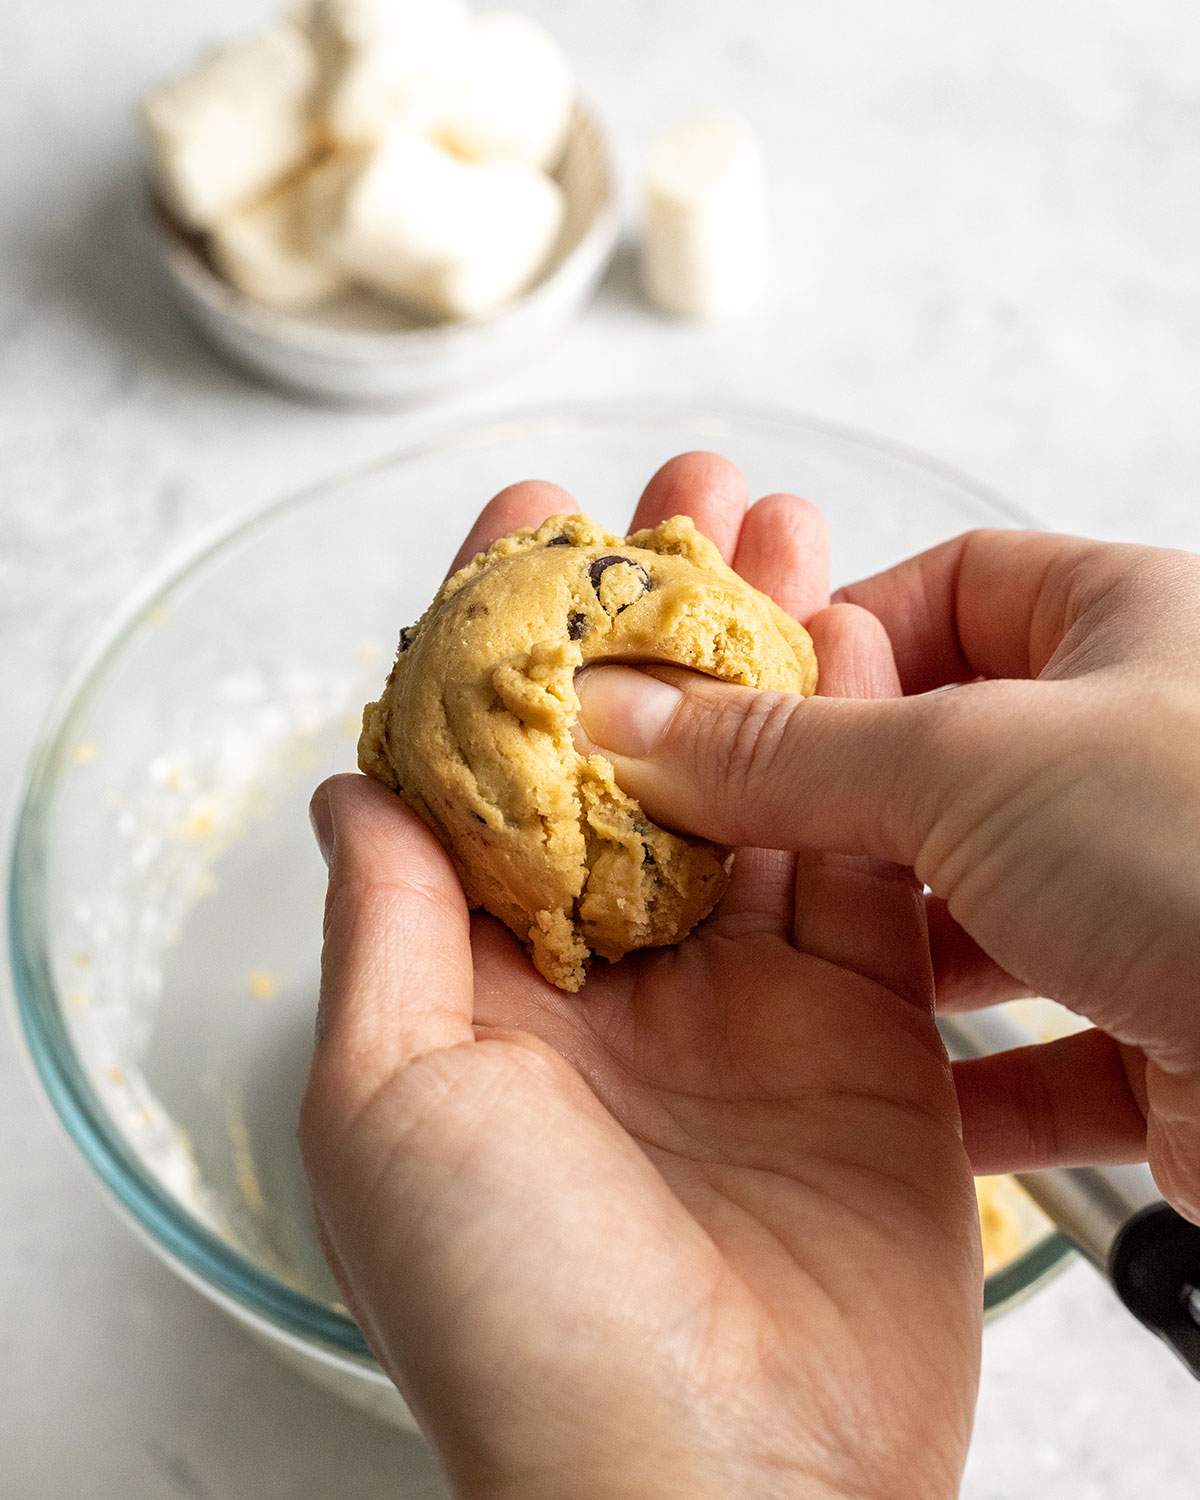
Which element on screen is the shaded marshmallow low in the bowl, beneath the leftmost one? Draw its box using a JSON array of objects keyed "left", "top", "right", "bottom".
[{"left": 209, "top": 168, "right": 350, "bottom": 312}]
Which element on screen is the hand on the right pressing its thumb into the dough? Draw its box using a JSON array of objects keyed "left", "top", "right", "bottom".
[{"left": 581, "top": 531, "right": 1200, "bottom": 1220}]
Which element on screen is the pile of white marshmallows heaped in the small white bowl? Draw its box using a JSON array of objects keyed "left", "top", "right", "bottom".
[{"left": 143, "top": 0, "right": 575, "bottom": 320}]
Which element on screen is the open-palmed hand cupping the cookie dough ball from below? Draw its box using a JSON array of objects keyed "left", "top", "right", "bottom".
[{"left": 302, "top": 455, "right": 981, "bottom": 1500}]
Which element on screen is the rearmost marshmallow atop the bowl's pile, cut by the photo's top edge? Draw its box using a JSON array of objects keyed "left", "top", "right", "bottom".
[{"left": 306, "top": 0, "right": 468, "bottom": 144}]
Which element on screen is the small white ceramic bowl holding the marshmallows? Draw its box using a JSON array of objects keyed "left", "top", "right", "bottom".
[{"left": 150, "top": 107, "right": 620, "bottom": 405}]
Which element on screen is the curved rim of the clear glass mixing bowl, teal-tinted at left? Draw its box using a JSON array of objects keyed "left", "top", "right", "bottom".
[{"left": 6, "top": 399, "right": 1071, "bottom": 1376}]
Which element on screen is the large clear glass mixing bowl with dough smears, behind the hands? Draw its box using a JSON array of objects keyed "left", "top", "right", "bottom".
[{"left": 8, "top": 402, "right": 1068, "bottom": 1421}]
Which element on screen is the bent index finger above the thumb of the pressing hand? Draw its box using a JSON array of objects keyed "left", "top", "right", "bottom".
[{"left": 834, "top": 531, "right": 1140, "bottom": 693}]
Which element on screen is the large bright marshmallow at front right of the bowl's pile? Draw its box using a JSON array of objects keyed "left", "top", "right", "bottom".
[{"left": 312, "top": 128, "right": 564, "bottom": 318}]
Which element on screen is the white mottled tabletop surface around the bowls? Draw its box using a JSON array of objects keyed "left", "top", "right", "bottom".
[{"left": 0, "top": 0, "right": 1200, "bottom": 1500}]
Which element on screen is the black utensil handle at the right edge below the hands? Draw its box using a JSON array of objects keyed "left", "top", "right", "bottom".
[{"left": 1109, "top": 1203, "right": 1200, "bottom": 1380}]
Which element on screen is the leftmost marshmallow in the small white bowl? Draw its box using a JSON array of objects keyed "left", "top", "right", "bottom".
[{"left": 143, "top": 21, "right": 317, "bottom": 230}]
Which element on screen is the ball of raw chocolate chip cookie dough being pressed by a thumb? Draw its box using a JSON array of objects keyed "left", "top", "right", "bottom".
[{"left": 359, "top": 515, "right": 816, "bottom": 990}]
